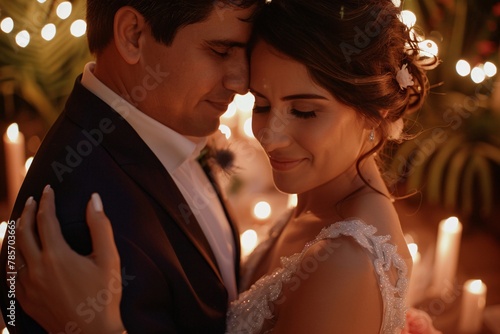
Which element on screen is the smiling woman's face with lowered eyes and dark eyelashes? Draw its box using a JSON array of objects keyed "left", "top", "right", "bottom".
[{"left": 250, "top": 41, "right": 369, "bottom": 194}]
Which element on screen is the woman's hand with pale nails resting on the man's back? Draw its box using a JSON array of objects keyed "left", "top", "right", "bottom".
[{"left": 16, "top": 186, "right": 124, "bottom": 334}]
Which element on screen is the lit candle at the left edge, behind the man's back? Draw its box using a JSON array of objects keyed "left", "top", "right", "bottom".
[{"left": 3, "top": 123, "right": 26, "bottom": 209}]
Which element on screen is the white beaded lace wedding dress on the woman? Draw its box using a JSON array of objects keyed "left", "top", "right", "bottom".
[{"left": 226, "top": 215, "right": 408, "bottom": 334}]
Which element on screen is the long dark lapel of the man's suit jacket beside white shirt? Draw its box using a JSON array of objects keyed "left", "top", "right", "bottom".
[{"left": 66, "top": 78, "right": 222, "bottom": 282}]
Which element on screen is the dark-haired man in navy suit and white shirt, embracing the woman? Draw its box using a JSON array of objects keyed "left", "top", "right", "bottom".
[{"left": 0, "top": 0, "right": 257, "bottom": 334}]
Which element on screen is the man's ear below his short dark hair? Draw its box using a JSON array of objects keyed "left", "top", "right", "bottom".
[{"left": 113, "top": 6, "right": 146, "bottom": 65}]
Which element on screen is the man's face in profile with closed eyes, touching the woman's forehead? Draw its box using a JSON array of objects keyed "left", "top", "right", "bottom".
[{"left": 138, "top": 7, "right": 253, "bottom": 136}]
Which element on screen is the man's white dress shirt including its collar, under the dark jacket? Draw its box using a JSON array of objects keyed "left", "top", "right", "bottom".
[{"left": 81, "top": 62, "right": 237, "bottom": 301}]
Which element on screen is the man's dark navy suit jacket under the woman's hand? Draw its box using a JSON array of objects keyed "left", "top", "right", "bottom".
[{"left": 0, "top": 78, "right": 239, "bottom": 334}]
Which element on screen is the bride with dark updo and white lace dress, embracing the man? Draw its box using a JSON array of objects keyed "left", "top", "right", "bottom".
[{"left": 13, "top": 0, "right": 440, "bottom": 334}]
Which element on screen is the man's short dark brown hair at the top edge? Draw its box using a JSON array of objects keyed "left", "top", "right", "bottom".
[{"left": 87, "top": 0, "right": 260, "bottom": 54}]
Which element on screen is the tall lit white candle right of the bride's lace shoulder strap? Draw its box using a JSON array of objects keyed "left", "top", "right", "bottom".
[{"left": 431, "top": 217, "right": 462, "bottom": 294}]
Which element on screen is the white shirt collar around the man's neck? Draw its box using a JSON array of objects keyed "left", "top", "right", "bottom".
[{"left": 81, "top": 62, "right": 207, "bottom": 173}]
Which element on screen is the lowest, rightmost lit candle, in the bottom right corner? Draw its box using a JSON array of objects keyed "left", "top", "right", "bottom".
[{"left": 458, "top": 279, "right": 486, "bottom": 333}]
